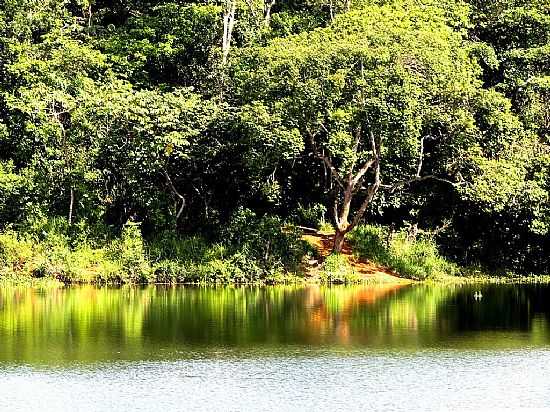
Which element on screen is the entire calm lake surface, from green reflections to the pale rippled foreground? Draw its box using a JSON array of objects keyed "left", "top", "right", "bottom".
[{"left": 0, "top": 285, "right": 550, "bottom": 411}]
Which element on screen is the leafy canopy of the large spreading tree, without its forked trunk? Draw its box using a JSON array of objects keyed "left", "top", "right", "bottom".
[{"left": 233, "top": 3, "right": 480, "bottom": 187}]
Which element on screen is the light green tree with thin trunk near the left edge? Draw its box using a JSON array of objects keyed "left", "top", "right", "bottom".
[{"left": 4, "top": 27, "right": 109, "bottom": 224}]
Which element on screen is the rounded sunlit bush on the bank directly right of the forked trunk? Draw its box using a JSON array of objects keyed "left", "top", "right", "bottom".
[{"left": 349, "top": 225, "right": 458, "bottom": 280}]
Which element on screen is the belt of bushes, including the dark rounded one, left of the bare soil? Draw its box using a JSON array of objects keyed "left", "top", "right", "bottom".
[{"left": 0, "top": 211, "right": 311, "bottom": 284}]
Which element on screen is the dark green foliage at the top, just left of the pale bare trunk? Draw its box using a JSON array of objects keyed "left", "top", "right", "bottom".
[{"left": 99, "top": 3, "right": 222, "bottom": 86}]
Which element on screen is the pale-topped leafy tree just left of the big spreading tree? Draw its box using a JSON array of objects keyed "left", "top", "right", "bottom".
[{"left": 96, "top": 84, "right": 217, "bottom": 227}]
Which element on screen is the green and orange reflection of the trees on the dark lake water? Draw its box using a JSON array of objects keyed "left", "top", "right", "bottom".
[{"left": 0, "top": 285, "right": 550, "bottom": 361}]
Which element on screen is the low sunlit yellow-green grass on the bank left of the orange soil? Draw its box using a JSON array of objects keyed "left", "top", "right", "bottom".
[{"left": 0, "top": 226, "right": 300, "bottom": 284}]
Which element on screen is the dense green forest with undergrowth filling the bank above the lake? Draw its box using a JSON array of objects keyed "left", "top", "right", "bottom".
[{"left": 0, "top": 0, "right": 550, "bottom": 283}]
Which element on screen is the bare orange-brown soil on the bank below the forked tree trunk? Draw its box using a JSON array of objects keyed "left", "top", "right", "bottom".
[{"left": 302, "top": 232, "right": 412, "bottom": 283}]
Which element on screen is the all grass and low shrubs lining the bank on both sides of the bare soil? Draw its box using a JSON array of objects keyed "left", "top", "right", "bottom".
[{"left": 0, "top": 220, "right": 550, "bottom": 284}]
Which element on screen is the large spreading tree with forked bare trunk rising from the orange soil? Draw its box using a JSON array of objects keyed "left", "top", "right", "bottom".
[{"left": 234, "top": 4, "right": 488, "bottom": 252}]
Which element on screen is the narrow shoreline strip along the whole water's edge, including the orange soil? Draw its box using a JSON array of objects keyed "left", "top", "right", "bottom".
[{"left": 0, "top": 228, "right": 550, "bottom": 287}]
